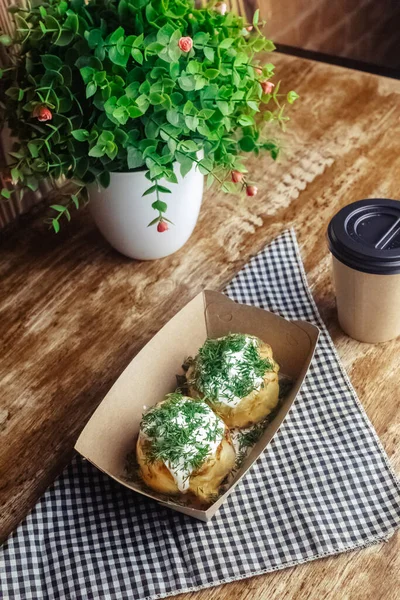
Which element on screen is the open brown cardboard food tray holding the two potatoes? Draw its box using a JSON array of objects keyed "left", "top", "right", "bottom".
[{"left": 75, "top": 290, "right": 319, "bottom": 521}]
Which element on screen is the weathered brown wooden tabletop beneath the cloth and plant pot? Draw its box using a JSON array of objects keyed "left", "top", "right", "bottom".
[{"left": 0, "top": 55, "right": 400, "bottom": 600}]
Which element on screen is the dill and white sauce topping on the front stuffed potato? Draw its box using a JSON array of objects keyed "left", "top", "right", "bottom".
[{"left": 141, "top": 393, "right": 225, "bottom": 471}]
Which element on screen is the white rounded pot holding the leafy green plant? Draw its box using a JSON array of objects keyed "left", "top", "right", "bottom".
[{"left": 89, "top": 163, "right": 204, "bottom": 260}]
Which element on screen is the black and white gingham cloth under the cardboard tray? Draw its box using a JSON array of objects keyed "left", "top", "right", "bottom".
[{"left": 0, "top": 232, "right": 400, "bottom": 600}]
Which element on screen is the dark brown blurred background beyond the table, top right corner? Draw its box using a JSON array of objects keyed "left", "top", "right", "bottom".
[{"left": 242, "top": 0, "right": 400, "bottom": 77}]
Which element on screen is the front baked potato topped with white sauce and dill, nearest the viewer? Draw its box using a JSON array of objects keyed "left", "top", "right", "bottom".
[{"left": 136, "top": 393, "right": 236, "bottom": 503}]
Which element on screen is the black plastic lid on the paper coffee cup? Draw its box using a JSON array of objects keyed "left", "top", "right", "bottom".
[{"left": 328, "top": 198, "right": 400, "bottom": 275}]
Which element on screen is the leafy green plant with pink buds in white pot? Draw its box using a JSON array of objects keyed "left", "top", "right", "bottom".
[{"left": 0, "top": 0, "right": 297, "bottom": 259}]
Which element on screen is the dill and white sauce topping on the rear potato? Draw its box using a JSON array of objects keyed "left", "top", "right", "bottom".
[{"left": 189, "top": 333, "right": 273, "bottom": 403}]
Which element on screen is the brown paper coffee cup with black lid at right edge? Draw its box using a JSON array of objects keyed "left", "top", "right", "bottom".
[{"left": 328, "top": 198, "right": 400, "bottom": 343}]
